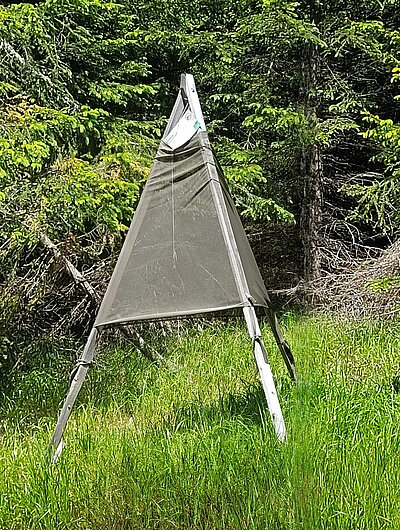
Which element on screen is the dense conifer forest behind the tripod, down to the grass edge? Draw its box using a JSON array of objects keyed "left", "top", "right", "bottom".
[{"left": 0, "top": 0, "right": 400, "bottom": 374}]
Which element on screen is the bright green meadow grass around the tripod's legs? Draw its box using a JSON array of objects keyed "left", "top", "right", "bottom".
[{"left": 0, "top": 315, "right": 400, "bottom": 530}]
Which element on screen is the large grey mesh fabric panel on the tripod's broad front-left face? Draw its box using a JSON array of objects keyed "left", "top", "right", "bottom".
[{"left": 95, "top": 134, "right": 243, "bottom": 326}]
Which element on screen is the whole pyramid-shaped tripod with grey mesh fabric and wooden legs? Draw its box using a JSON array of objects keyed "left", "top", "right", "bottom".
[{"left": 52, "top": 74, "right": 296, "bottom": 456}]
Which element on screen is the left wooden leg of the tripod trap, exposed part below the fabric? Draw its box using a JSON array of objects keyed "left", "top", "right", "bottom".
[{"left": 50, "top": 328, "right": 100, "bottom": 463}]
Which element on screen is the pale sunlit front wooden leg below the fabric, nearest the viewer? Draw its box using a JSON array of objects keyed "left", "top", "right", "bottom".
[{"left": 243, "top": 306, "right": 286, "bottom": 442}]
